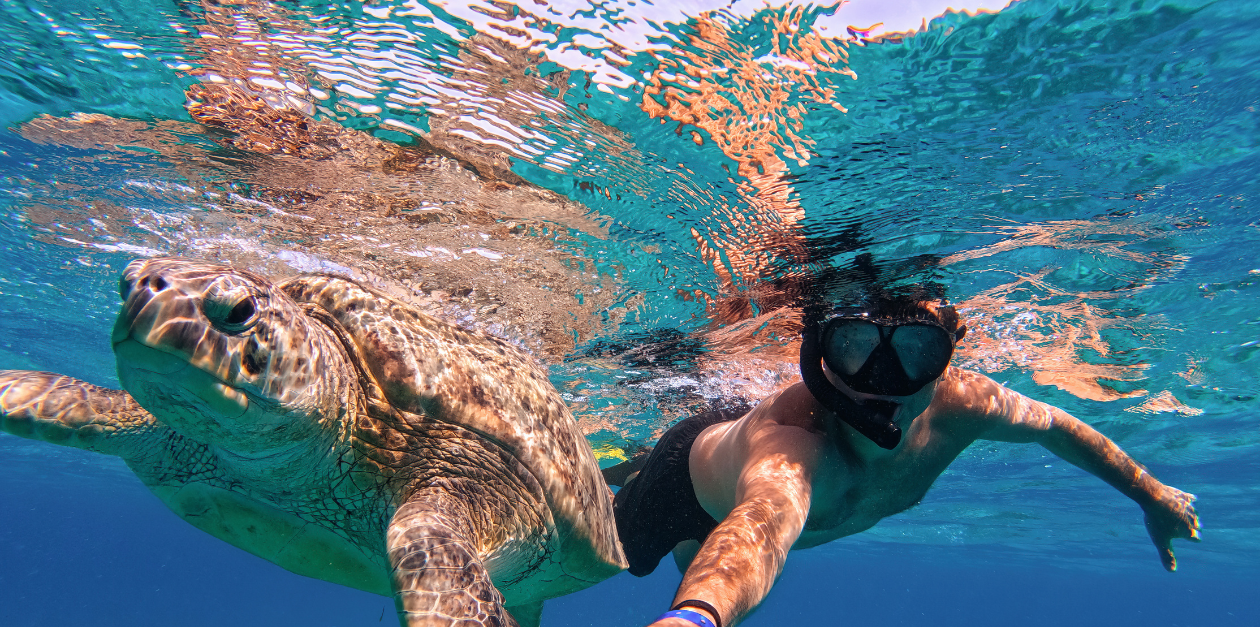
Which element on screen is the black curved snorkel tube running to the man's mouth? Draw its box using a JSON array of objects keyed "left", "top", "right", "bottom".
[{"left": 800, "top": 324, "right": 901, "bottom": 451}]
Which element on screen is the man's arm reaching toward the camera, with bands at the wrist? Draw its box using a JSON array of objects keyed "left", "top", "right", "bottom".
[{"left": 653, "top": 426, "right": 819, "bottom": 627}]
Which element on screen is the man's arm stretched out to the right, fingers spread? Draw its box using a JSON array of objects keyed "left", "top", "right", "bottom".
[{"left": 980, "top": 381, "right": 1200, "bottom": 570}]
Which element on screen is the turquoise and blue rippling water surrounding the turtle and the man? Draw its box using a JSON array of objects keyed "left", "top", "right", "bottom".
[{"left": 0, "top": 0, "right": 1260, "bottom": 626}]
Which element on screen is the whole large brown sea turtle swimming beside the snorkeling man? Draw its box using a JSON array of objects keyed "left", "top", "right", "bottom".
[{"left": 0, "top": 259, "right": 625, "bottom": 627}]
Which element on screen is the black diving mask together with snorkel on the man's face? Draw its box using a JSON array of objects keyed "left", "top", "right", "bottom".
[{"left": 800, "top": 308, "right": 966, "bottom": 449}]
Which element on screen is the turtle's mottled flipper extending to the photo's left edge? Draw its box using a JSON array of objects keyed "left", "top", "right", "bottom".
[{"left": 0, "top": 370, "right": 164, "bottom": 458}]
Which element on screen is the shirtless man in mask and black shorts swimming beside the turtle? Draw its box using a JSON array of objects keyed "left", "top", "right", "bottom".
[{"left": 615, "top": 297, "right": 1198, "bottom": 627}]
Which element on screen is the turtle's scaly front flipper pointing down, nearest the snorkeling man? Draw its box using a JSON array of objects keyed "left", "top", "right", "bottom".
[{"left": 386, "top": 489, "right": 517, "bottom": 627}]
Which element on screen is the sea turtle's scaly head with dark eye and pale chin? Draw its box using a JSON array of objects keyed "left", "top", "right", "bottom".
[{"left": 112, "top": 258, "right": 352, "bottom": 458}]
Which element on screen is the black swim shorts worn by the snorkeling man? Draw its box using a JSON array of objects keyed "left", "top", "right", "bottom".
[{"left": 612, "top": 407, "right": 748, "bottom": 577}]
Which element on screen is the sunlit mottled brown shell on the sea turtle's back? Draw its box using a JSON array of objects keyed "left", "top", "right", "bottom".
[{"left": 278, "top": 274, "right": 626, "bottom": 597}]
